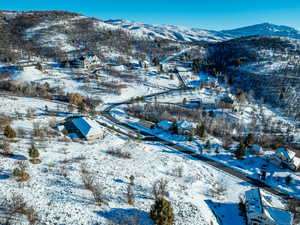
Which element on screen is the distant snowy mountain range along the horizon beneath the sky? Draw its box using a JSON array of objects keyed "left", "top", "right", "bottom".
[{"left": 104, "top": 20, "right": 300, "bottom": 42}]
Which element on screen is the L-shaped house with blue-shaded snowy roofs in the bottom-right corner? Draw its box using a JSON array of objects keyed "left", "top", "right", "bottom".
[{"left": 245, "top": 188, "right": 293, "bottom": 225}]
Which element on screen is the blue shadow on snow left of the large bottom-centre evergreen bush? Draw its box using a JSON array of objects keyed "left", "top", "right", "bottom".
[{"left": 95, "top": 208, "right": 153, "bottom": 225}]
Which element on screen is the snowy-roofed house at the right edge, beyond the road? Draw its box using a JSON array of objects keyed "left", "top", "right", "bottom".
[{"left": 271, "top": 148, "right": 300, "bottom": 171}]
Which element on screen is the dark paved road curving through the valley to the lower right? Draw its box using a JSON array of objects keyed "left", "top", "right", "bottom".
[{"left": 103, "top": 89, "right": 295, "bottom": 199}]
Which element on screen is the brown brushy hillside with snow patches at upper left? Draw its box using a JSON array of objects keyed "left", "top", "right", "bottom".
[{"left": 0, "top": 11, "right": 191, "bottom": 62}]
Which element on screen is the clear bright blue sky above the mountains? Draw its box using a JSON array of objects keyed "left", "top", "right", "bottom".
[{"left": 0, "top": 0, "right": 300, "bottom": 30}]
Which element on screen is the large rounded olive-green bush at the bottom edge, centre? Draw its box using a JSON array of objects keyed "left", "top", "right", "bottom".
[{"left": 150, "top": 197, "right": 175, "bottom": 225}]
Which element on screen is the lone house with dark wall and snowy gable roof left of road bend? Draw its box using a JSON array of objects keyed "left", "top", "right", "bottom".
[{"left": 65, "top": 116, "right": 103, "bottom": 140}]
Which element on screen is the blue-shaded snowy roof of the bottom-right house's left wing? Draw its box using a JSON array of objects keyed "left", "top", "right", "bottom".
[{"left": 245, "top": 188, "right": 263, "bottom": 215}]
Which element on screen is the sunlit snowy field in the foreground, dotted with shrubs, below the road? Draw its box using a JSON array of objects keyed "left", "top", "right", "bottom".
[{"left": 0, "top": 98, "right": 283, "bottom": 225}]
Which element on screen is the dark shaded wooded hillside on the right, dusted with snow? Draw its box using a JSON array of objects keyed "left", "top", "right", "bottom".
[{"left": 207, "top": 36, "right": 300, "bottom": 120}]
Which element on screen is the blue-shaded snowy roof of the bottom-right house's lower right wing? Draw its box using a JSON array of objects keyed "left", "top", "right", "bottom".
[{"left": 264, "top": 207, "right": 293, "bottom": 225}]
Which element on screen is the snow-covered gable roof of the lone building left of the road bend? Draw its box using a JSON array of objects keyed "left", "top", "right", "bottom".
[{"left": 72, "top": 117, "right": 102, "bottom": 137}]
